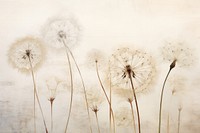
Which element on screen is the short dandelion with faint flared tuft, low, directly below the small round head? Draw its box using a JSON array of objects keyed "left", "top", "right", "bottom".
[{"left": 86, "top": 89, "right": 103, "bottom": 133}]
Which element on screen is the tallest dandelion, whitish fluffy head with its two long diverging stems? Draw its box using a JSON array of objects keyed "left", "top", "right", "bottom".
[{"left": 44, "top": 17, "right": 92, "bottom": 133}]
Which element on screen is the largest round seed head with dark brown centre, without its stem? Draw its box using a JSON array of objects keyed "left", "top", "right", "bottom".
[{"left": 110, "top": 48, "right": 155, "bottom": 92}]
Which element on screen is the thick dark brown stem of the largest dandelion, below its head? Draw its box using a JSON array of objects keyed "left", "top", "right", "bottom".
[{"left": 129, "top": 73, "right": 141, "bottom": 133}]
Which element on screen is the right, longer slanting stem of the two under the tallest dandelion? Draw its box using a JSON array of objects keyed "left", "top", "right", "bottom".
[{"left": 64, "top": 42, "right": 92, "bottom": 133}]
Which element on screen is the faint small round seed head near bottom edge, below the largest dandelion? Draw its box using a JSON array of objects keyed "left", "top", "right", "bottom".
[{"left": 115, "top": 107, "right": 133, "bottom": 127}]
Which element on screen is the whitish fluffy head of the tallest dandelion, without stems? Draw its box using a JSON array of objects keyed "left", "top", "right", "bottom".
[{"left": 43, "top": 17, "right": 80, "bottom": 48}]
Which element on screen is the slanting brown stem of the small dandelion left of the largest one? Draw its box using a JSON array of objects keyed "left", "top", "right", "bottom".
[{"left": 95, "top": 62, "right": 115, "bottom": 133}]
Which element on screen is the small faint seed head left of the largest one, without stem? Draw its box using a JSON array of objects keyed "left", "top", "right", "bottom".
[{"left": 86, "top": 49, "right": 106, "bottom": 68}]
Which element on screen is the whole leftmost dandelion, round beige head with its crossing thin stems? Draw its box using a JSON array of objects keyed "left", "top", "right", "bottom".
[{"left": 8, "top": 37, "right": 48, "bottom": 133}]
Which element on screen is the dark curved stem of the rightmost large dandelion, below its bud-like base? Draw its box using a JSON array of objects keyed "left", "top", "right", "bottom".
[{"left": 158, "top": 67, "right": 172, "bottom": 133}]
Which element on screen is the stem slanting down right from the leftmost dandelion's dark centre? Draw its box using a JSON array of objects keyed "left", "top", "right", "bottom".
[{"left": 28, "top": 56, "right": 48, "bottom": 133}]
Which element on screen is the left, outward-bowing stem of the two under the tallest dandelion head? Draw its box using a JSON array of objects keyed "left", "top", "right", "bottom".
[{"left": 65, "top": 50, "right": 74, "bottom": 133}]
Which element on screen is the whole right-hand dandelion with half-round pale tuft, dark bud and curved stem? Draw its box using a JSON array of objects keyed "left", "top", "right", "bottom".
[{"left": 158, "top": 42, "right": 194, "bottom": 133}]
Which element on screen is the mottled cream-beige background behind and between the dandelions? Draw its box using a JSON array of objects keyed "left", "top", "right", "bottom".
[{"left": 0, "top": 0, "right": 200, "bottom": 133}]
